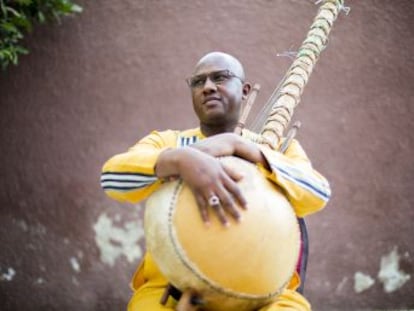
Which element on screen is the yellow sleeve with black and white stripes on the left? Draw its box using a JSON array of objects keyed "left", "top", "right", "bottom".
[{"left": 101, "top": 131, "right": 177, "bottom": 203}]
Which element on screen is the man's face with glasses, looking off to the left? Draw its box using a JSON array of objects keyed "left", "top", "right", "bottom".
[{"left": 189, "top": 58, "right": 246, "bottom": 126}]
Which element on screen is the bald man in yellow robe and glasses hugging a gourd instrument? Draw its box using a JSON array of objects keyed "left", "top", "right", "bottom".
[{"left": 101, "top": 52, "right": 330, "bottom": 311}]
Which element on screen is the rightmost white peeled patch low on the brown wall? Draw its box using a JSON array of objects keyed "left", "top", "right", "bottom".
[{"left": 378, "top": 247, "right": 411, "bottom": 293}]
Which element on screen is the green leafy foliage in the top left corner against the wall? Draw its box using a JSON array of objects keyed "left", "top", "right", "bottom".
[{"left": 0, "top": 0, "right": 82, "bottom": 70}]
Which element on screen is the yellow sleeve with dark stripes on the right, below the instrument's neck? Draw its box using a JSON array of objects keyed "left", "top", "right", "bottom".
[{"left": 259, "top": 140, "right": 331, "bottom": 217}]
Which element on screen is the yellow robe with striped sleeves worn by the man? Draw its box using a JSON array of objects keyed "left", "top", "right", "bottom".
[{"left": 101, "top": 128, "right": 330, "bottom": 311}]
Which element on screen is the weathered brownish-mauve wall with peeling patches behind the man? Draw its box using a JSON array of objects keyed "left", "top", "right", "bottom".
[{"left": 0, "top": 0, "right": 414, "bottom": 310}]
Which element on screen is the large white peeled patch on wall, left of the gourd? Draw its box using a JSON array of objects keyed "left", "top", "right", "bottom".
[{"left": 93, "top": 213, "right": 144, "bottom": 266}]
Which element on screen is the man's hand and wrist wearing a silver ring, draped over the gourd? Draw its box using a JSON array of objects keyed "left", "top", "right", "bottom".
[{"left": 156, "top": 147, "right": 246, "bottom": 225}]
